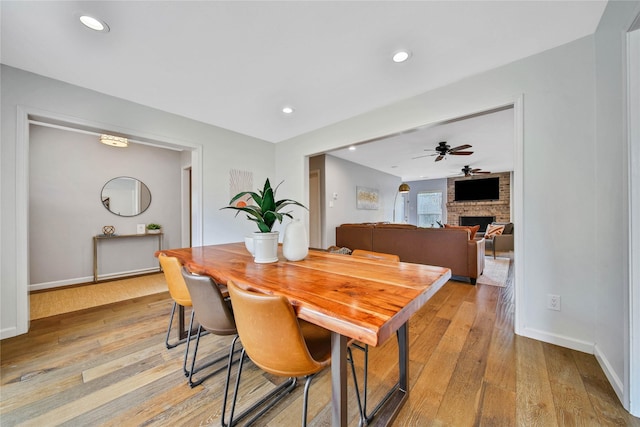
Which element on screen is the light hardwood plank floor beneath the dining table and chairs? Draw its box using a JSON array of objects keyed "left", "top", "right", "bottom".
[{"left": 0, "top": 260, "right": 640, "bottom": 427}]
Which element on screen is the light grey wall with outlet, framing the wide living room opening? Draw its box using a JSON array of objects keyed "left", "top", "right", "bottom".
[{"left": 276, "top": 32, "right": 604, "bottom": 382}]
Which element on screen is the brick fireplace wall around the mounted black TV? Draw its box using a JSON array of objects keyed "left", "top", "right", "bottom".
[{"left": 447, "top": 172, "right": 511, "bottom": 229}]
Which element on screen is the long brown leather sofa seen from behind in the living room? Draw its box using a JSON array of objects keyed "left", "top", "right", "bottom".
[{"left": 336, "top": 223, "right": 485, "bottom": 285}]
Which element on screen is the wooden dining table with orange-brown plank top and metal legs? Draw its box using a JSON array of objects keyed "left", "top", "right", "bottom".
[{"left": 156, "top": 243, "right": 451, "bottom": 426}]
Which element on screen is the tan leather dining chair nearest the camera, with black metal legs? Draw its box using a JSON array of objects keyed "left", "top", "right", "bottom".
[{"left": 222, "top": 281, "right": 359, "bottom": 426}]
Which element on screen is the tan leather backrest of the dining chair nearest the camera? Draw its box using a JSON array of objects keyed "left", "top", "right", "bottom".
[{"left": 227, "top": 281, "right": 325, "bottom": 377}]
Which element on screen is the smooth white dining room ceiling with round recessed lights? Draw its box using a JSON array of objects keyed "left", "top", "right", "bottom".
[{"left": 0, "top": 0, "right": 606, "bottom": 144}]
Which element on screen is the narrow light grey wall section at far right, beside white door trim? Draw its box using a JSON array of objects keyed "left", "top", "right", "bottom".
[{"left": 592, "top": 2, "right": 640, "bottom": 415}]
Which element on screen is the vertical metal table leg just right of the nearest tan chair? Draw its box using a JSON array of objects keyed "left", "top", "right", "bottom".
[{"left": 331, "top": 332, "right": 347, "bottom": 427}]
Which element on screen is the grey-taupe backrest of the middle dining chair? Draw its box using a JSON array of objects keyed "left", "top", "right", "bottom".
[{"left": 182, "top": 267, "right": 237, "bottom": 335}]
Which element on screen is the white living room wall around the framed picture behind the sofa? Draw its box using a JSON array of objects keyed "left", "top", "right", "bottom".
[{"left": 324, "top": 155, "right": 400, "bottom": 247}]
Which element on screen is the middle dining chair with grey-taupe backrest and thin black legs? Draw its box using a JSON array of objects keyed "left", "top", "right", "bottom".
[{"left": 182, "top": 267, "right": 238, "bottom": 394}]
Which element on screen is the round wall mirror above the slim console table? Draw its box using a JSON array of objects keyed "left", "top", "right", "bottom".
[{"left": 100, "top": 176, "right": 151, "bottom": 216}]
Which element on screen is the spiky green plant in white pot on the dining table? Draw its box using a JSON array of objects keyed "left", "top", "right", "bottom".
[{"left": 221, "top": 178, "right": 307, "bottom": 263}]
